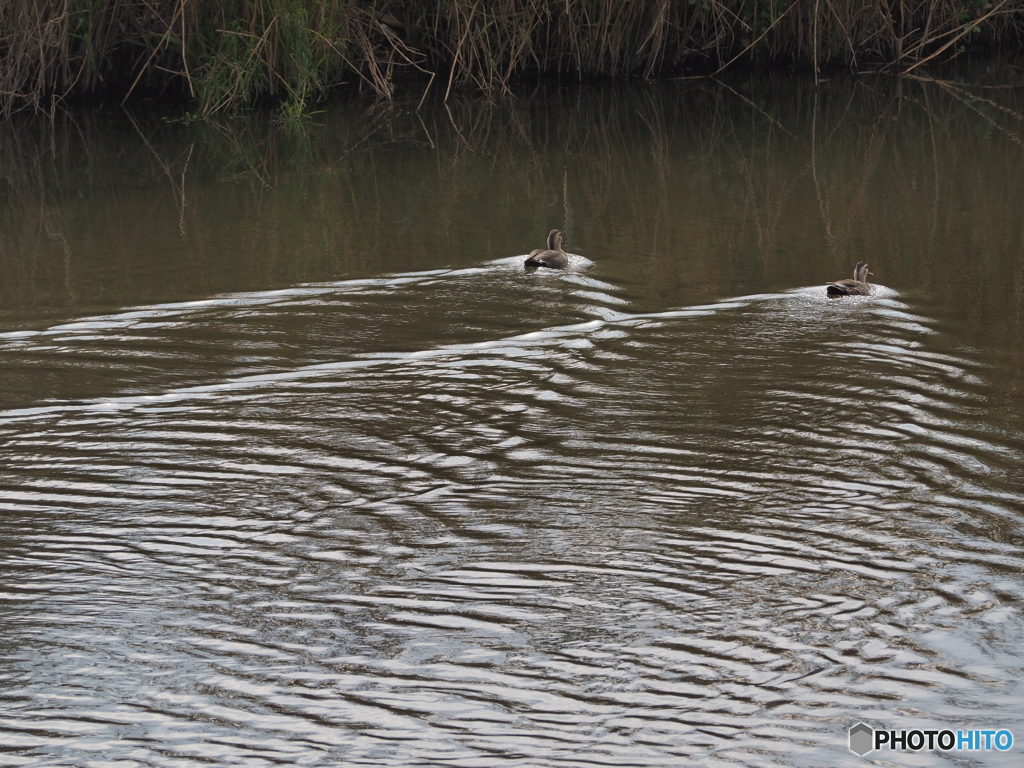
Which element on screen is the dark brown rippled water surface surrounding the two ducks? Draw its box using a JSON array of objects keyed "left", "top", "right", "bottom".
[{"left": 0, "top": 77, "right": 1024, "bottom": 768}]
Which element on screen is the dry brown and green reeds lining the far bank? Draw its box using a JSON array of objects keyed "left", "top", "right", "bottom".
[{"left": 6, "top": 0, "right": 1024, "bottom": 116}]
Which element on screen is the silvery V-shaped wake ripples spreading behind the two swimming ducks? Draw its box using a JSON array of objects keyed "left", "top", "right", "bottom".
[{"left": 0, "top": 268, "right": 1024, "bottom": 766}]
